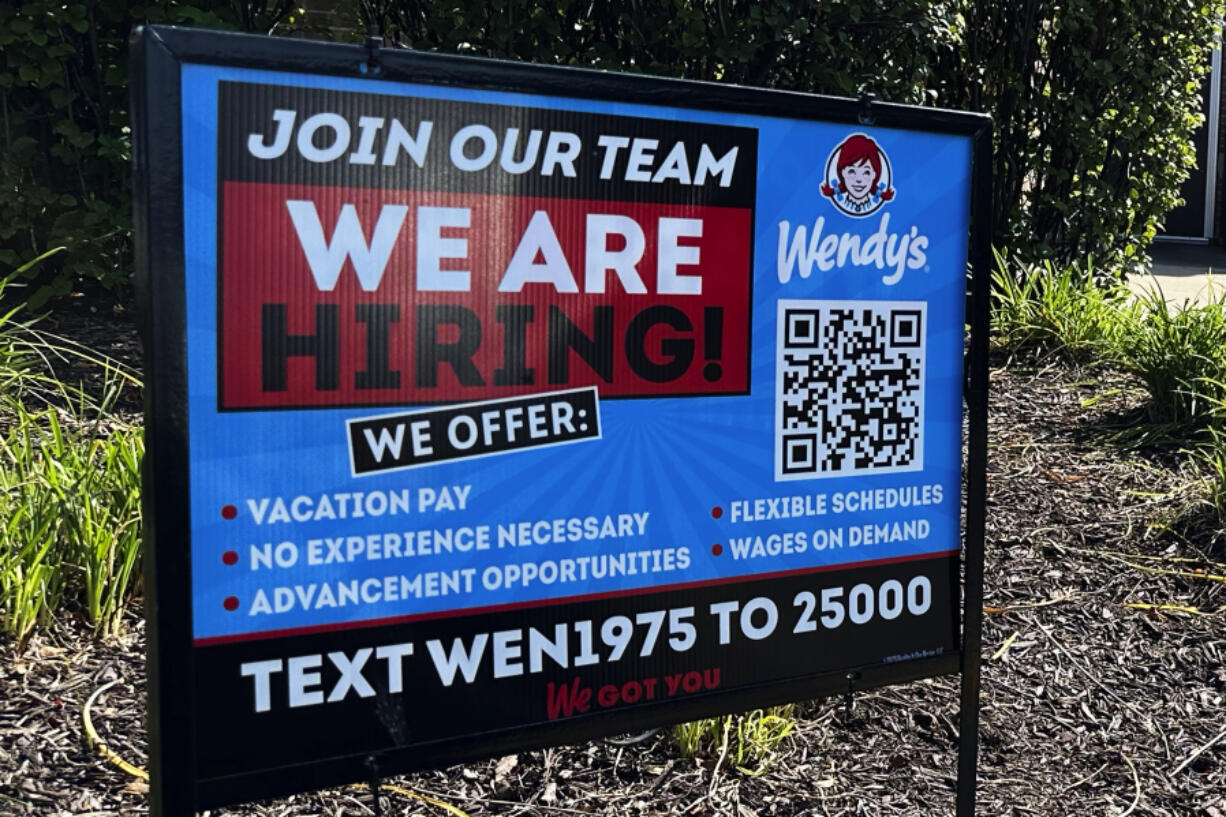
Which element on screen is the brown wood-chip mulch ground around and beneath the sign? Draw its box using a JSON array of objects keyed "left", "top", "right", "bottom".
[{"left": 0, "top": 323, "right": 1226, "bottom": 817}]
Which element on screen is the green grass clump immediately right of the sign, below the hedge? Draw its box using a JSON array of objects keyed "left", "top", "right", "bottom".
[{"left": 992, "top": 253, "right": 1138, "bottom": 362}]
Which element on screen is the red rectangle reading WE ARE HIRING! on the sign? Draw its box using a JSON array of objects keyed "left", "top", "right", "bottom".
[{"left": 224, "top": 182, "right": 753, "bottom": 409}]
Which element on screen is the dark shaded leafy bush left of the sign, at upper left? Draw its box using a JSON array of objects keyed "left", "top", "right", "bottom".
[{"left": 0, "top": 0, "right": 306, "bottom": 307}]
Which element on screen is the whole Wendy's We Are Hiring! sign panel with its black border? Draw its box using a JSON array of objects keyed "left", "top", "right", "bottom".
[{"left": 137, "top": 22, "right": 982, "bottom": 813}]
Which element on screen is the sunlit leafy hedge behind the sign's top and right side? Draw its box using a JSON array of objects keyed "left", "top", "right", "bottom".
[{"left": 365, "top": 0, "right": 1224, "bottom": 271}]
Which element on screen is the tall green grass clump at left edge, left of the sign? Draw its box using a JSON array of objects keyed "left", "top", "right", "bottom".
[{"left": 0, "top": 267, "right": 143, "bottom": 642}]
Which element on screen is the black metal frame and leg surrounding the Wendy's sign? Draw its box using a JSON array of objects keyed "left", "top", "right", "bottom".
[{"left": 131, "top": 26, "right": 992, "bottom": 817}]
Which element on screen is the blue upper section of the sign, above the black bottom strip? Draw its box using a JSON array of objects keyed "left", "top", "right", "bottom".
[{"left": 181, "top": 65, "right": 971, "bottom": 642}]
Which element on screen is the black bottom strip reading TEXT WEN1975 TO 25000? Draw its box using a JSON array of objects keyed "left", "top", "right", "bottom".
[{"left": 194, "top": 556, "right": 960, "bottom": 808}]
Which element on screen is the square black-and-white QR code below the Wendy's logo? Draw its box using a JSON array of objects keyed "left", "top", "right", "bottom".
[{"left": 775, "top": 301, "right": 928, "bottom": 481}]
